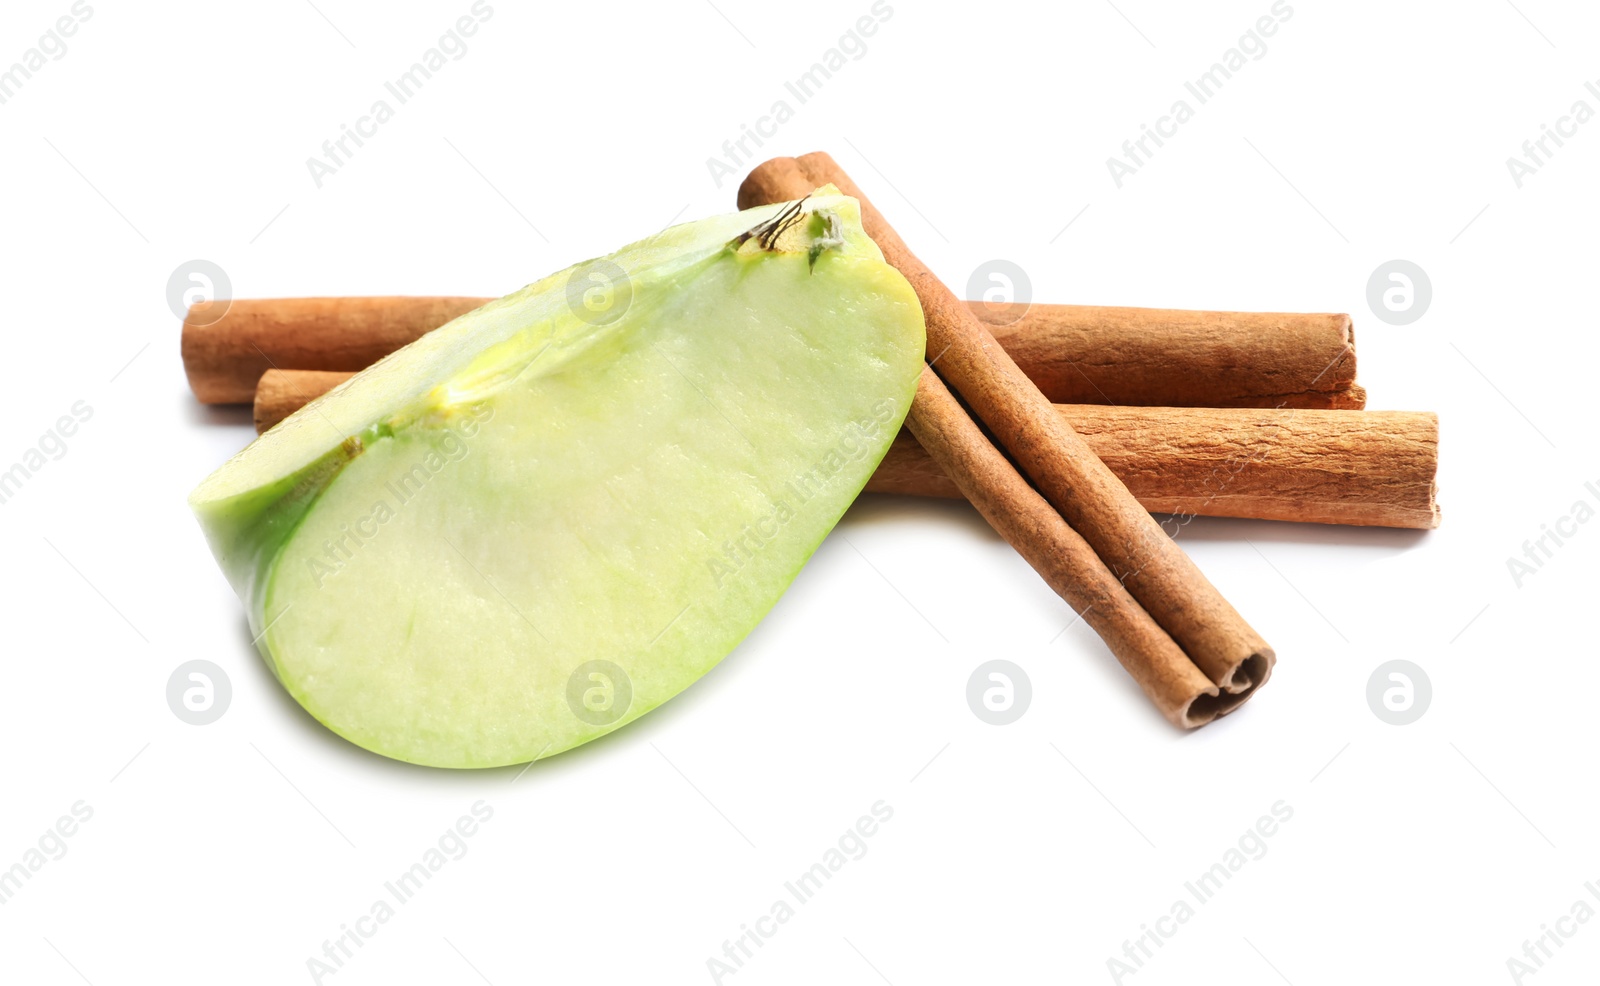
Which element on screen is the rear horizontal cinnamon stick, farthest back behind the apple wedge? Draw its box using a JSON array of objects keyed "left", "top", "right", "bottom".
[{"left": 182, "top": 298, "right": 1366, "bottom": 408}]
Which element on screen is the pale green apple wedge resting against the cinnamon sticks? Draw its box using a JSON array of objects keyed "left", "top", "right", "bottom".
[{"left": 190, "top": 187, "right": 923, "bottom": 767}]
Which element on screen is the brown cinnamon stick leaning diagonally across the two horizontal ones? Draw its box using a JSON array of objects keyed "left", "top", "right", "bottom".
[{"left": 739, "top": 152, "right": 1275, "bottom": 727}]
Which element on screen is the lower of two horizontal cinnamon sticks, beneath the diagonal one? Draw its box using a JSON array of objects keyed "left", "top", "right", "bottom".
[{"left": 256, "top": 370, "right": 1438, "bottom": 530}]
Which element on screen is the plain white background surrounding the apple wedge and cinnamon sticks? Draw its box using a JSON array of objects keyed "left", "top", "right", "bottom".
[{"left": 0, "top": 0, "right": 1600, "bottom": 986}]
